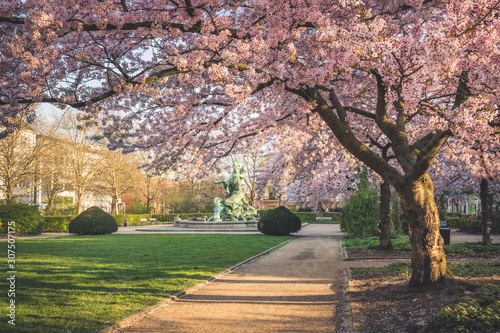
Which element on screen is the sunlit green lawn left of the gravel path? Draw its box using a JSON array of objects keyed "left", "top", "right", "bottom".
[{"left": 0, "top": 235, "right": 291, "bottom": 333}]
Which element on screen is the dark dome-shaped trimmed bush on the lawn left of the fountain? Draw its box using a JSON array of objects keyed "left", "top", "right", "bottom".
[{"left": 68, "top": 206, "right": 118, "bottom": 235}]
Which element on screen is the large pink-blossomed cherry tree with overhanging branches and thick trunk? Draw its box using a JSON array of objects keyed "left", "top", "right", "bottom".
[{"left": 0, "top": 0, "right": 500, "bottom": 286}]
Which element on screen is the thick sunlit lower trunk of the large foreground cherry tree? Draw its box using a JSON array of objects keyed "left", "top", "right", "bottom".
[{"left": 396, "top": 173, "right": 453, "bottom": 287}]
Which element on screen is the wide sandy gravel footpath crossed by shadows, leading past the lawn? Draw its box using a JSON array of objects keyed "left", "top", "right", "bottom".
[{"left": 114, "top": 225, "right": 345, "bottom": 332}]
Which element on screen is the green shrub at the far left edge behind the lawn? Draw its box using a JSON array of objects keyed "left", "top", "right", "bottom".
[{"left": 0, "top": 203, "right": 44, "bottom": 235}]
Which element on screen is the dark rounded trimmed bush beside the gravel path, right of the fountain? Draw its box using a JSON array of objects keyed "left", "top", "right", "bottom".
[{"left": 257, "top": 206, "right": 302, "bottom": 236}]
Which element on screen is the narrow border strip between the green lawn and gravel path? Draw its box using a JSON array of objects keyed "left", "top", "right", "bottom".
[{"left": 98, "top": 236, "right": 296, "bottom": 333}]
